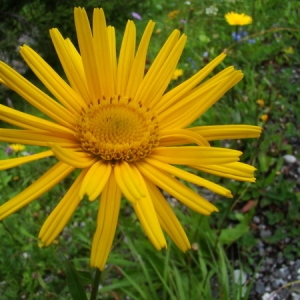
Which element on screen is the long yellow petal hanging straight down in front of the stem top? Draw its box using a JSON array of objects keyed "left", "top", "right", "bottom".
[{"left": 90, "top": 173, "right": 121, "bottom": 270}]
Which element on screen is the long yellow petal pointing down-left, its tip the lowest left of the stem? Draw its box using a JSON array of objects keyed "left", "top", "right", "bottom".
[{"left": 39, "top": 170, "right": 87, "bottom": 246}]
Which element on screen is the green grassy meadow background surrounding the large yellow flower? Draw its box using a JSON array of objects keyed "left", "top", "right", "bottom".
[{"left": 0, "top": 0, "right": 300, "bottom": 300}]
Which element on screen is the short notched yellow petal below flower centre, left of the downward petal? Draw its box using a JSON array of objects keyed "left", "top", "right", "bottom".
[{"left": 79, "top": 161, "right": 112, "bottom": 201}]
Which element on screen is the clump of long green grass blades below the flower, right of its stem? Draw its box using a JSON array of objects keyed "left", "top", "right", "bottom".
[{"left": 96, "top": 214, "right": 253, "bottom": 300}]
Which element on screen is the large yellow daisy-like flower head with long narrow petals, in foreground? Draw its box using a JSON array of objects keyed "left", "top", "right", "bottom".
[{"left": 0, "top": 8, "right": 261, "bottom": 270}]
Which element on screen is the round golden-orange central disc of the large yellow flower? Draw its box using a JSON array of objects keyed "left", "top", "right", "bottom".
[{"left": 76, "top": 97, "right": 159, "bottom": 161}]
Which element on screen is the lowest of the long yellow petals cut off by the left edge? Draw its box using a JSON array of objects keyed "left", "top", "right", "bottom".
[{"left": 0, "top": 162, "right": 75, "bottom": 220}]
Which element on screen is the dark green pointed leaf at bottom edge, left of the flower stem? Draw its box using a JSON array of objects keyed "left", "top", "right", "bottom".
[{"left": 64, "top": 260, "right": 87, "bottom": 300}]
